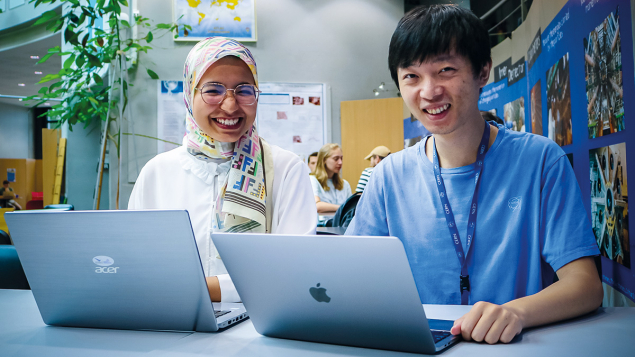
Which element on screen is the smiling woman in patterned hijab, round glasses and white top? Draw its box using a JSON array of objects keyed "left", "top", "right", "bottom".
[{"left": 128, "top": 37, "right": 317, "bottom": 302}]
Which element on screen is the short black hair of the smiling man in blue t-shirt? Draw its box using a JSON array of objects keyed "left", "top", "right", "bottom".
[{"left": 388, "top": 5, "right": 492, "bottom": 87}]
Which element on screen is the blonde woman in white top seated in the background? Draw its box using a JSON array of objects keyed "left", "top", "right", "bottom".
[{"left": 310, "top": 144, "right": 351, "bottom": 214}]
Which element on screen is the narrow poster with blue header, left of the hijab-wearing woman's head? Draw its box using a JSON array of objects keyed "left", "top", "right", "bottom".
[{"left": 157, "top": 81, "right": 186, "bottom": 154}]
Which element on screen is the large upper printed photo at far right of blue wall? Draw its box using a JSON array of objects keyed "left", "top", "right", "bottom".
[{"left": 584, "top": 8, "right": 630, "bottom": 138}]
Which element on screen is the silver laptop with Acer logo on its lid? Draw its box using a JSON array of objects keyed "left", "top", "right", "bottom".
[{"left": 5, "top": 210, "right": 247, "bottom": 332}]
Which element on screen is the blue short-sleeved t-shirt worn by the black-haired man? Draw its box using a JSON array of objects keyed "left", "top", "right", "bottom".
[{"left": 346, "top": 127, "right": 599, "bottom": 304}]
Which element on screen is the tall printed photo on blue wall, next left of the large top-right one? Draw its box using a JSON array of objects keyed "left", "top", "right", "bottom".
[{"left": 547, "top": 53, "right": 572, "bottom": 146}]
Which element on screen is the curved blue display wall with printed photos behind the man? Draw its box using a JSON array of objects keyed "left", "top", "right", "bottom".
[{"left": 479, "top": 0, "right": 635, "bottom": 301}]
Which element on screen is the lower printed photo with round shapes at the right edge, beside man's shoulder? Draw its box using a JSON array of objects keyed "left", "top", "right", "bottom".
[{"left": 589, "top": 143, "right": 631, "bottom": 269}]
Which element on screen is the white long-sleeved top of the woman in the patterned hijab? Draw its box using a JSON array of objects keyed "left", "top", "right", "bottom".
[{"left": 128, "top": 145, "right": 317, "bottom": 302}]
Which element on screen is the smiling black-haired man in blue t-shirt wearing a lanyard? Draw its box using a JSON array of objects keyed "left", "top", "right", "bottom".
[{"left": 346, "top": 5, "right": 602, "bottom": 343}]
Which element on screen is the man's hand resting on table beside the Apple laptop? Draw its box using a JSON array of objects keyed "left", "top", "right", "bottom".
[{"left": 450, "top": 301, "right": 523, "bottom": 344}]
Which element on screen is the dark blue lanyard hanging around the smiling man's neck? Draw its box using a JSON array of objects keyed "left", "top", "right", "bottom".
[{"left": 432, "top": 122, "right": 490, "bottom": 305}]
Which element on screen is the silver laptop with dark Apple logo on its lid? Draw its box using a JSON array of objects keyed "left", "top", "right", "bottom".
[{"left": 212, "top": 233, "right": 458, "bottom": 353}]
